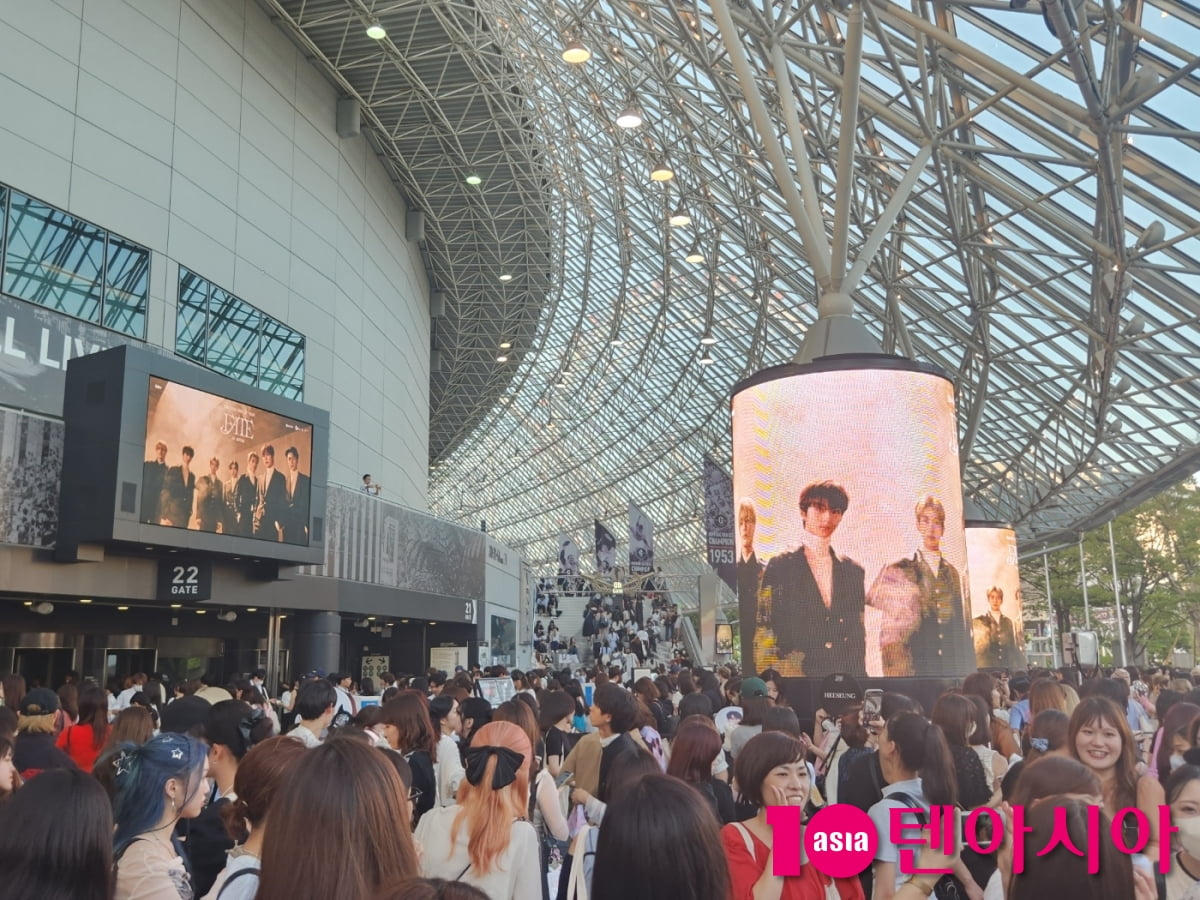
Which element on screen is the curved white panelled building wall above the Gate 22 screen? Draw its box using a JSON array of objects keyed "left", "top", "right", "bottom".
[{"left": 0, "top": 0, "right": 430, "bottom": 509}]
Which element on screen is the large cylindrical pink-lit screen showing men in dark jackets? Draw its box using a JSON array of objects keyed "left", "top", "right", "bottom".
[{"left": 733, "top": 365, "right": 974, "bottom": 677}]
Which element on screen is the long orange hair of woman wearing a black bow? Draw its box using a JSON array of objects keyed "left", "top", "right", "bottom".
[{"left": 446, "top": 721, "right": 533, "bottom": 875}]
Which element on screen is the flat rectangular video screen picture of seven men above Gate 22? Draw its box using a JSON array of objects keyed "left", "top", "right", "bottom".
[{"left": 140, "top": 377, "right": 312, "bottom": 545}]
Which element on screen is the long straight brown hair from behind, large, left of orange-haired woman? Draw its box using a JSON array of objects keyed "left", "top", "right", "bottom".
[{"left": 257, "top": 740, "right": 419, "bottom": 900}]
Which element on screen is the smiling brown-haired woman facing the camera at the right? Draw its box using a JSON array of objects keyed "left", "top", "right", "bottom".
[{"left": 1067, "top": 696, "right": 1165, "bottom": 859}]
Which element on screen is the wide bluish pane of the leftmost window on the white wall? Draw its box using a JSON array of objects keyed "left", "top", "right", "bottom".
[{"left": 4, "top": 191, "right": 104, "bottom": 322}]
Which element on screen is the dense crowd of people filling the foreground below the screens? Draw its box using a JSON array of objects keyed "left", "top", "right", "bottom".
[{"left": 7, "top": 667, "right": 1200, "bottom": 900}]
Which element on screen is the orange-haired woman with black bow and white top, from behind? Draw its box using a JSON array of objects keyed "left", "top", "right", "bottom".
[{"left": 415, "top": 721, "right": 542, "bottom": 900}]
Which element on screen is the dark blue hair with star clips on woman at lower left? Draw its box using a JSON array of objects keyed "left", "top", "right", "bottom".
[{"left": 106, "top": 732, "right": 209, "bottom": 857}]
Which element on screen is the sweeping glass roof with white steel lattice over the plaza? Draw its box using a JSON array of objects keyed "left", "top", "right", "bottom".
[{"left": 260, "top": 0, "right": 1200, "bottom": 607}]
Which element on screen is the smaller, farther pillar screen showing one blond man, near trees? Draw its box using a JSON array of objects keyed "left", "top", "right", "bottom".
[{"left": 967, "top": 526, "right": 1025, "bottom": 668}]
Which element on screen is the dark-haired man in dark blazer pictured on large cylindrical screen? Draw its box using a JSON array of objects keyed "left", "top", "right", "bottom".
[{"left": 755, "top": 481, "right": 866, "bottom": 678}]
